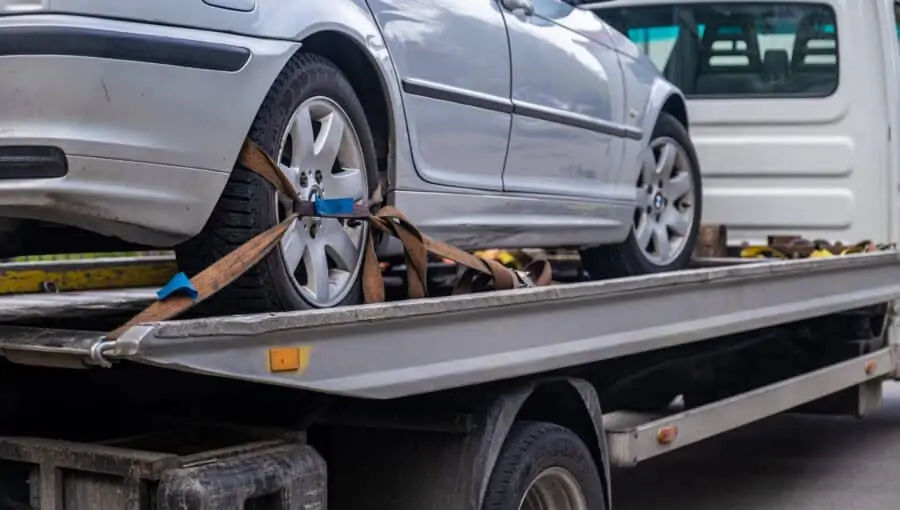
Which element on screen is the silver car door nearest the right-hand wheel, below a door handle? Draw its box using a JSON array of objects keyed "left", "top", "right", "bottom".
[{"left": 500, "top": 0, "right": 640, "bottom": 198}]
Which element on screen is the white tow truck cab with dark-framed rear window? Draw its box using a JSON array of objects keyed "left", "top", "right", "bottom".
[{"left": 588, "top": 0, "right": 900, "bottom": 247}]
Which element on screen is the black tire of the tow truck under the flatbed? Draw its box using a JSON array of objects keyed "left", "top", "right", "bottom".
[{"left": 482, "top": 421, "right": 606, "bottom": 510}]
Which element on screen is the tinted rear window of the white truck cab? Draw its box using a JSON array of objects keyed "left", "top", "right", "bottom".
[{"left": 601, "top": 2, "right": 839, "bottom": 98}]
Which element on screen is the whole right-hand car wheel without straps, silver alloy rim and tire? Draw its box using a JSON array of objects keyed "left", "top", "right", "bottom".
[{"left": 581, "top": 112, "right": 703, "bottom": 279}]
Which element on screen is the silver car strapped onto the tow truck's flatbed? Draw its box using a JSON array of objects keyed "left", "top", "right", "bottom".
[{"left": 0, "top": 0, "right": 701, "bottom": 313}]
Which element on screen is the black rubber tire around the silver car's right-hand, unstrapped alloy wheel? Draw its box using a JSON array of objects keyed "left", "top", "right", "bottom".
[{"left": 581, "top": 112, "right": 703, "bottom": 279}]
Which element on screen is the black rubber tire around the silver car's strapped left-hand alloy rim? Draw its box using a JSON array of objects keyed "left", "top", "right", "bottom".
[{"left": 176, "top": 53, "right": 377, "bottom": 315}]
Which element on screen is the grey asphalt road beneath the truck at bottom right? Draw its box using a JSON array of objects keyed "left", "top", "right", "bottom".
[{"left": 613, "top": 383, "right": 900, "bottom": 510}]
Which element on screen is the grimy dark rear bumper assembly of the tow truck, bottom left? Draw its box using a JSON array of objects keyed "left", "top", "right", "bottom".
[{"left": 0, "top": 431, "right": 327, "bottom": 510}]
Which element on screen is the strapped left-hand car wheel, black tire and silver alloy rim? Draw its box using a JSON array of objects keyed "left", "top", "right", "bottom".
[{"left": 176, "top": 53, "right": 377, "bottom": 314}]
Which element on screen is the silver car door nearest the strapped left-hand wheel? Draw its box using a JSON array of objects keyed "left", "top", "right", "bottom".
[{"left": 368, "top": 0, "right": 512, "bottom": 190}]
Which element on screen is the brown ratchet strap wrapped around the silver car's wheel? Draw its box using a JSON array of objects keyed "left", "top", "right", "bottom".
[{"left": 106, "top": 140, "right": 551, "bottom": 340}]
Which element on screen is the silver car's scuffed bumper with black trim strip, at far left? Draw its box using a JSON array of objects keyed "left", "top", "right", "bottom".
[{"left": 0, "top": 14, "right": 299, "bottom": 246}]
